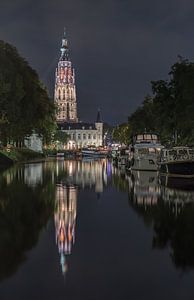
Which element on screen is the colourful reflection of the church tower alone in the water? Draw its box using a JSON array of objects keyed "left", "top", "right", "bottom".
[{"left": 55, "top": 184, "right": 77, "bottom": 274}]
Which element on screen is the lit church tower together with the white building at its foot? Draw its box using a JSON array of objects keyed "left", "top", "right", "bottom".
[{"left": 54, "top": 32, "right": 103, "bottom": 149}]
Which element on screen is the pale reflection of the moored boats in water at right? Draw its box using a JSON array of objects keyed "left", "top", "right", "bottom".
[{"left": 129, "top": 171, "right": 194, "bottom": 216}]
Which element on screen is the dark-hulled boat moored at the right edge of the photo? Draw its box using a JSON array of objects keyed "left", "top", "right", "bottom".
[{"left": 159, "top": 146, "right": 194, "bottom": 177}]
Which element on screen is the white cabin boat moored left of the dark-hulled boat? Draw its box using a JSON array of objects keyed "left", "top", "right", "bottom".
[{"left": 130, "top": 133, "right": 164, "bottom": 171}]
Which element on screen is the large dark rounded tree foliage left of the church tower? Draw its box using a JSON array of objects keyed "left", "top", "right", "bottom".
[{"left": 0, "top": 41, "right": 55, "bottom": 144}]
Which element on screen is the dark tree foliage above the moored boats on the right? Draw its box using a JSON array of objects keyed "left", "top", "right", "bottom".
[{"left": 129, "top": 57, "right": 194, "bottom": 144}]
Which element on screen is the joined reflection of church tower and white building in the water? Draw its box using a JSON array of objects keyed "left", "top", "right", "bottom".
[{"left": 54, "top": 160, "right": 112, "bottom": 275}]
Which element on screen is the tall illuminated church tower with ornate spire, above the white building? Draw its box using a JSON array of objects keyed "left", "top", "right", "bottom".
[{"left": 54, "top": 31, "right": 78, "bottom": 123}]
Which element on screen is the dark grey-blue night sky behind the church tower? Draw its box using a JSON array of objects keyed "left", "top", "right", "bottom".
[{"left": 0, "top": 0, "right": 194, "bottom": 124}]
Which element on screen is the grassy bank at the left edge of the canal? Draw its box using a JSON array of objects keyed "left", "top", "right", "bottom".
[{"left": 0, "top": 148, "right": 45, "bottom": 165}]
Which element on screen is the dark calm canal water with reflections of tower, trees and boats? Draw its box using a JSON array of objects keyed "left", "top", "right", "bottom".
[{"left": 0, "top": 159, "right": 194, "bottom": 300}]
